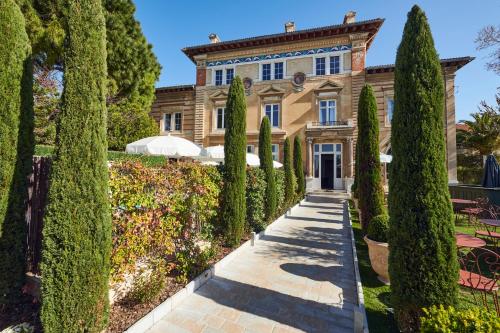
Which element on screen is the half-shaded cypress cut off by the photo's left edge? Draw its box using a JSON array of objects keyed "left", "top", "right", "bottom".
[{"left": 0, "top": 0, "right": 34, "bottom": 302}]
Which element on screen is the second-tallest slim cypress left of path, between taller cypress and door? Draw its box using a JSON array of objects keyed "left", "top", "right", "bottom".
[{"left": 259, "top": 117, "right": 277, "bottom": 222}]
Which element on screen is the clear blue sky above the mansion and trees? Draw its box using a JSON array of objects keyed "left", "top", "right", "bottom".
[{"left": 135, "top": 0, "right": 500, "bottom": 121}]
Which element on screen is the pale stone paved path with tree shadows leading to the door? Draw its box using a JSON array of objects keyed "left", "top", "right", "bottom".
[{"left": 148, "top": 193, "right": 357, "bottom": 333}]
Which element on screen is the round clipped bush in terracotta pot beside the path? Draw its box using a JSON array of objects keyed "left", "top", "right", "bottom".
[{"left": 364, "top": 214, "right": 390, "bottom": 284}]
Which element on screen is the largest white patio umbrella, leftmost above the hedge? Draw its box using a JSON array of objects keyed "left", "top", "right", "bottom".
[{"left": 125, "top": 135, "right": 201, "bottom": 158}]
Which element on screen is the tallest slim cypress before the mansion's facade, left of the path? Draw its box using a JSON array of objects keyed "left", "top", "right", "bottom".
[{"left": 222, "top": 76, "right": 247, "bottom": 246}]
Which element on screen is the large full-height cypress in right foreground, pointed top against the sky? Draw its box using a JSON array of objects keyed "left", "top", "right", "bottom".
[{"left": 389, "top": 6, "right": 458, "bottom": 332}]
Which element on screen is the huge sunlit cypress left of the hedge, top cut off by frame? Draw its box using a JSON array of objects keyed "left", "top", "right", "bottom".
[{"left": 40, "top": 0, "right": 111, "bottom": 333}]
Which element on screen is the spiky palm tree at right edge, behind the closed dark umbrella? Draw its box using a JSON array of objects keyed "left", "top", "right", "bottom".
[{"left": 457, "top": 94, "right": 500, "bottom": 155}]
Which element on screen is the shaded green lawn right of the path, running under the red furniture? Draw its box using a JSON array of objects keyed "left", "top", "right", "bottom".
[{"left": 349, "top": 200, "right": 494, "bottom": 333}]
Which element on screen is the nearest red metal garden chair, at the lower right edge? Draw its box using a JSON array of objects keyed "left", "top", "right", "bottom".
[{"left": 458, "top": 248, "right": 500, "bottom": 315}]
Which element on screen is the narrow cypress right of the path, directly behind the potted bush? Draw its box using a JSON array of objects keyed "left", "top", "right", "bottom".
[{"left": 356, "top": 84, "right": 384, "bottom": 231}]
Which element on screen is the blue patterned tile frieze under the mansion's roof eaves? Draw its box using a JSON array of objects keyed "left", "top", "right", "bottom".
[{"left": 207, "top": 45, "right": 351, "bottom": 67}]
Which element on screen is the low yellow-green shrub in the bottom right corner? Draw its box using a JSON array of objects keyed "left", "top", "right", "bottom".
[{"left": 420, "top": 305, "right": 500, "bottom": 333}]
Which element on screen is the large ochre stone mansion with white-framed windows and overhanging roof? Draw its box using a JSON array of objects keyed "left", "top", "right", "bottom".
[{"left": 151, "top": 12, "right": 473, "bottom": 189}]
